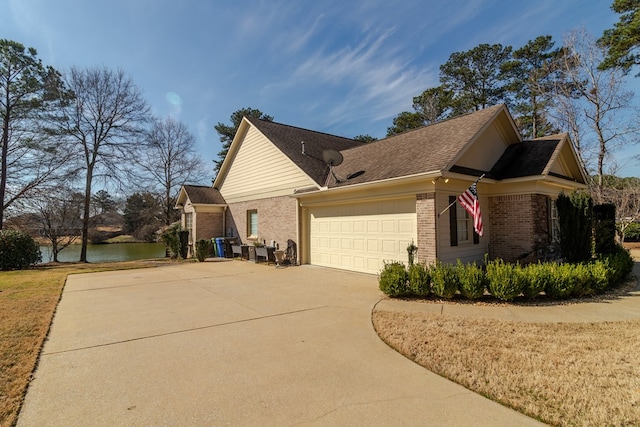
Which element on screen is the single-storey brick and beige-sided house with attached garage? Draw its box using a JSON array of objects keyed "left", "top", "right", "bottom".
[{"left": 178, "top": 105, "right": 587, "bottom": 273}]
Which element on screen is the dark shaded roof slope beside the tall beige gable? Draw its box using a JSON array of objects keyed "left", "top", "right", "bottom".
[{"left": 246, "top": 117, "right": 363, "bottom": 185}]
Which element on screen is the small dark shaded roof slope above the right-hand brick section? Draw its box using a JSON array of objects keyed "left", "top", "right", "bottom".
[{"left": 491, "top": 135, "right": 565, "bottom": 179}]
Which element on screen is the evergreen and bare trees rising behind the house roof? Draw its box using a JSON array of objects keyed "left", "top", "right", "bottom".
[{"left": 215, "top": 0, "right": 640, "bottom": 244}]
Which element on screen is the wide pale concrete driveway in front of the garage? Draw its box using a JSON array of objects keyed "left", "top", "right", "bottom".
[{"left": 18, "top": 261, "right": 537, "bottom": 426}]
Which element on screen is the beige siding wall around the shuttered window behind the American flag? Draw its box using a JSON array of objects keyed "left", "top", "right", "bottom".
[{"left": 436, "top": 191, "right": 489, "bottom": 263}]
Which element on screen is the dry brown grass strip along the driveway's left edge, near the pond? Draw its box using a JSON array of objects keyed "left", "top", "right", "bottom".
[{"left": 0, "top": 262, "right": 169, "bottom": 427}]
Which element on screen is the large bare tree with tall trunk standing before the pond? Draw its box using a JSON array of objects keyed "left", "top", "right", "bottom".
[{"left": 63, "top": 67, "right": 149, "bottom": 262}]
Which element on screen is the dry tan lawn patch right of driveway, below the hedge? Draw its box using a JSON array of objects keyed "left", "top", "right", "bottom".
[{"left": 373, "top": 311, "right": 640, "bottom": 426}]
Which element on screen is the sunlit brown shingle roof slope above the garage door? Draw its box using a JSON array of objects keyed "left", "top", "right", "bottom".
[{"left": 330, "top": 105, "right": 508, "bottom": 186}]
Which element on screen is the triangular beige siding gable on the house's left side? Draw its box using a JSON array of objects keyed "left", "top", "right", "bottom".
[{"left": 220, "top": 126, "right": 314, "bottom": 203}]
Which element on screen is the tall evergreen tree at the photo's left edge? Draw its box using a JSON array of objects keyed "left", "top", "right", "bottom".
[{"left": 0, "top": 39, "right": 71, "bottom": 229}]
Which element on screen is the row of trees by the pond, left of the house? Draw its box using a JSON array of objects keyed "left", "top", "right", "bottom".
[{"left": 0, "top": 39, "right": 207, "bottom": 262}]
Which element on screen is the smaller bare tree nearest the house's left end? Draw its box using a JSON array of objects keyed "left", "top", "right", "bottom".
[{"left": 140, "top": 117, "right": 208, "bottom": 225}]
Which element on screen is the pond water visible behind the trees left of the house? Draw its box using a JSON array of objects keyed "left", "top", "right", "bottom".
[{"left": 40, "top": 243, "right": 165, "bottom": 262}]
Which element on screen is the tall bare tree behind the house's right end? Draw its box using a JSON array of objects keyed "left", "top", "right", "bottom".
[{"left": 556, "top": 29, "right": 638, "bottom": 188}]
